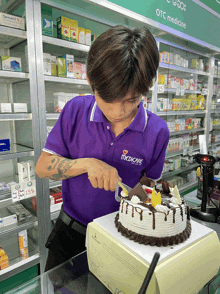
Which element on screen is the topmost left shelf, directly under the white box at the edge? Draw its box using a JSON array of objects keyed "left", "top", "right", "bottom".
[{"left": 0, "top": 26, "right": 27, "bottom": 49}]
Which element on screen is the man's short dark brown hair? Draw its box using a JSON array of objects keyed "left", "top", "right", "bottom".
[{"left": 87, "top": 25, "right": 159, "bottom": 103}]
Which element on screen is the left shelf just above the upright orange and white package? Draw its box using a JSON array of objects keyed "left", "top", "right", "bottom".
[{"left": 0, "top": 216, "right": 38, "bottom": 241}]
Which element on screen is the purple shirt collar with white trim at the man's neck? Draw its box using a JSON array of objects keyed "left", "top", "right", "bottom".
[{"left": 90, "top": 98, "right": 148, "bottom": 132}]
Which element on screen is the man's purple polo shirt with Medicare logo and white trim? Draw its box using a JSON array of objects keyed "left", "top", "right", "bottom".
[{"left": 44, "top": 95, "right": 169, "bottom": 225}]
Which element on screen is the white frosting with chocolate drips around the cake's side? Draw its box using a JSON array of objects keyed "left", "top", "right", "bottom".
[{"left": 119, "top": 199, "right": 187, "bottom": 237}]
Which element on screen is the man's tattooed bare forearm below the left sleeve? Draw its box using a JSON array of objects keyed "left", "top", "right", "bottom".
[{"left": 36, "top": 155, "right": 92, "bottom": 181}]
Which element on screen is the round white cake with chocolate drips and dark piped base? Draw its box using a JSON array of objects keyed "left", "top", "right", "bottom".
[{"left": 115, "top": 176, "right": 191, "bottom": 247}]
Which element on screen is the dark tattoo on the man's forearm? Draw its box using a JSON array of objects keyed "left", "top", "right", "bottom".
[{"left": 46, "top": 156, "right": 77, "bottom": 181}]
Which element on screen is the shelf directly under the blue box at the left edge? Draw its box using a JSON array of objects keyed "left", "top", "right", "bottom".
[{"left": 0, "top": 144, "right": 34, "bottom": 161}]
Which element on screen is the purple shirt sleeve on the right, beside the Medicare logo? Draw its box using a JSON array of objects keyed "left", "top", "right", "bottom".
[{"left": 146, "top": 127, "right": 170, "bottom": 180}]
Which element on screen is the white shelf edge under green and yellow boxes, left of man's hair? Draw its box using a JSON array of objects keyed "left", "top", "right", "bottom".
[{"left": 42, "top": 35, "right": 90, "bottom": 52}]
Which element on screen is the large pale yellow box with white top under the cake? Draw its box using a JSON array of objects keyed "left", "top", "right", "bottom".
[{"left": 86, "top": 212, "right": 220, "bottom": 294}]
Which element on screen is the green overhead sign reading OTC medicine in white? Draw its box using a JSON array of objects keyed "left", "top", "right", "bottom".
[{"left": 110, "top": 0, "right": 220, "bottom": 48}]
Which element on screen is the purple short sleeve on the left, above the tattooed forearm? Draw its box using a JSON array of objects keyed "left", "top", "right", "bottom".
[{"left": 44, "top": 103, "right": 70, "bottom": 158}]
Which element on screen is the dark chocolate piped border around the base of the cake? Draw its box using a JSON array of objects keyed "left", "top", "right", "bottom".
[{"left": 115, "top": 213, "right": 192, "bottom": 247}]
